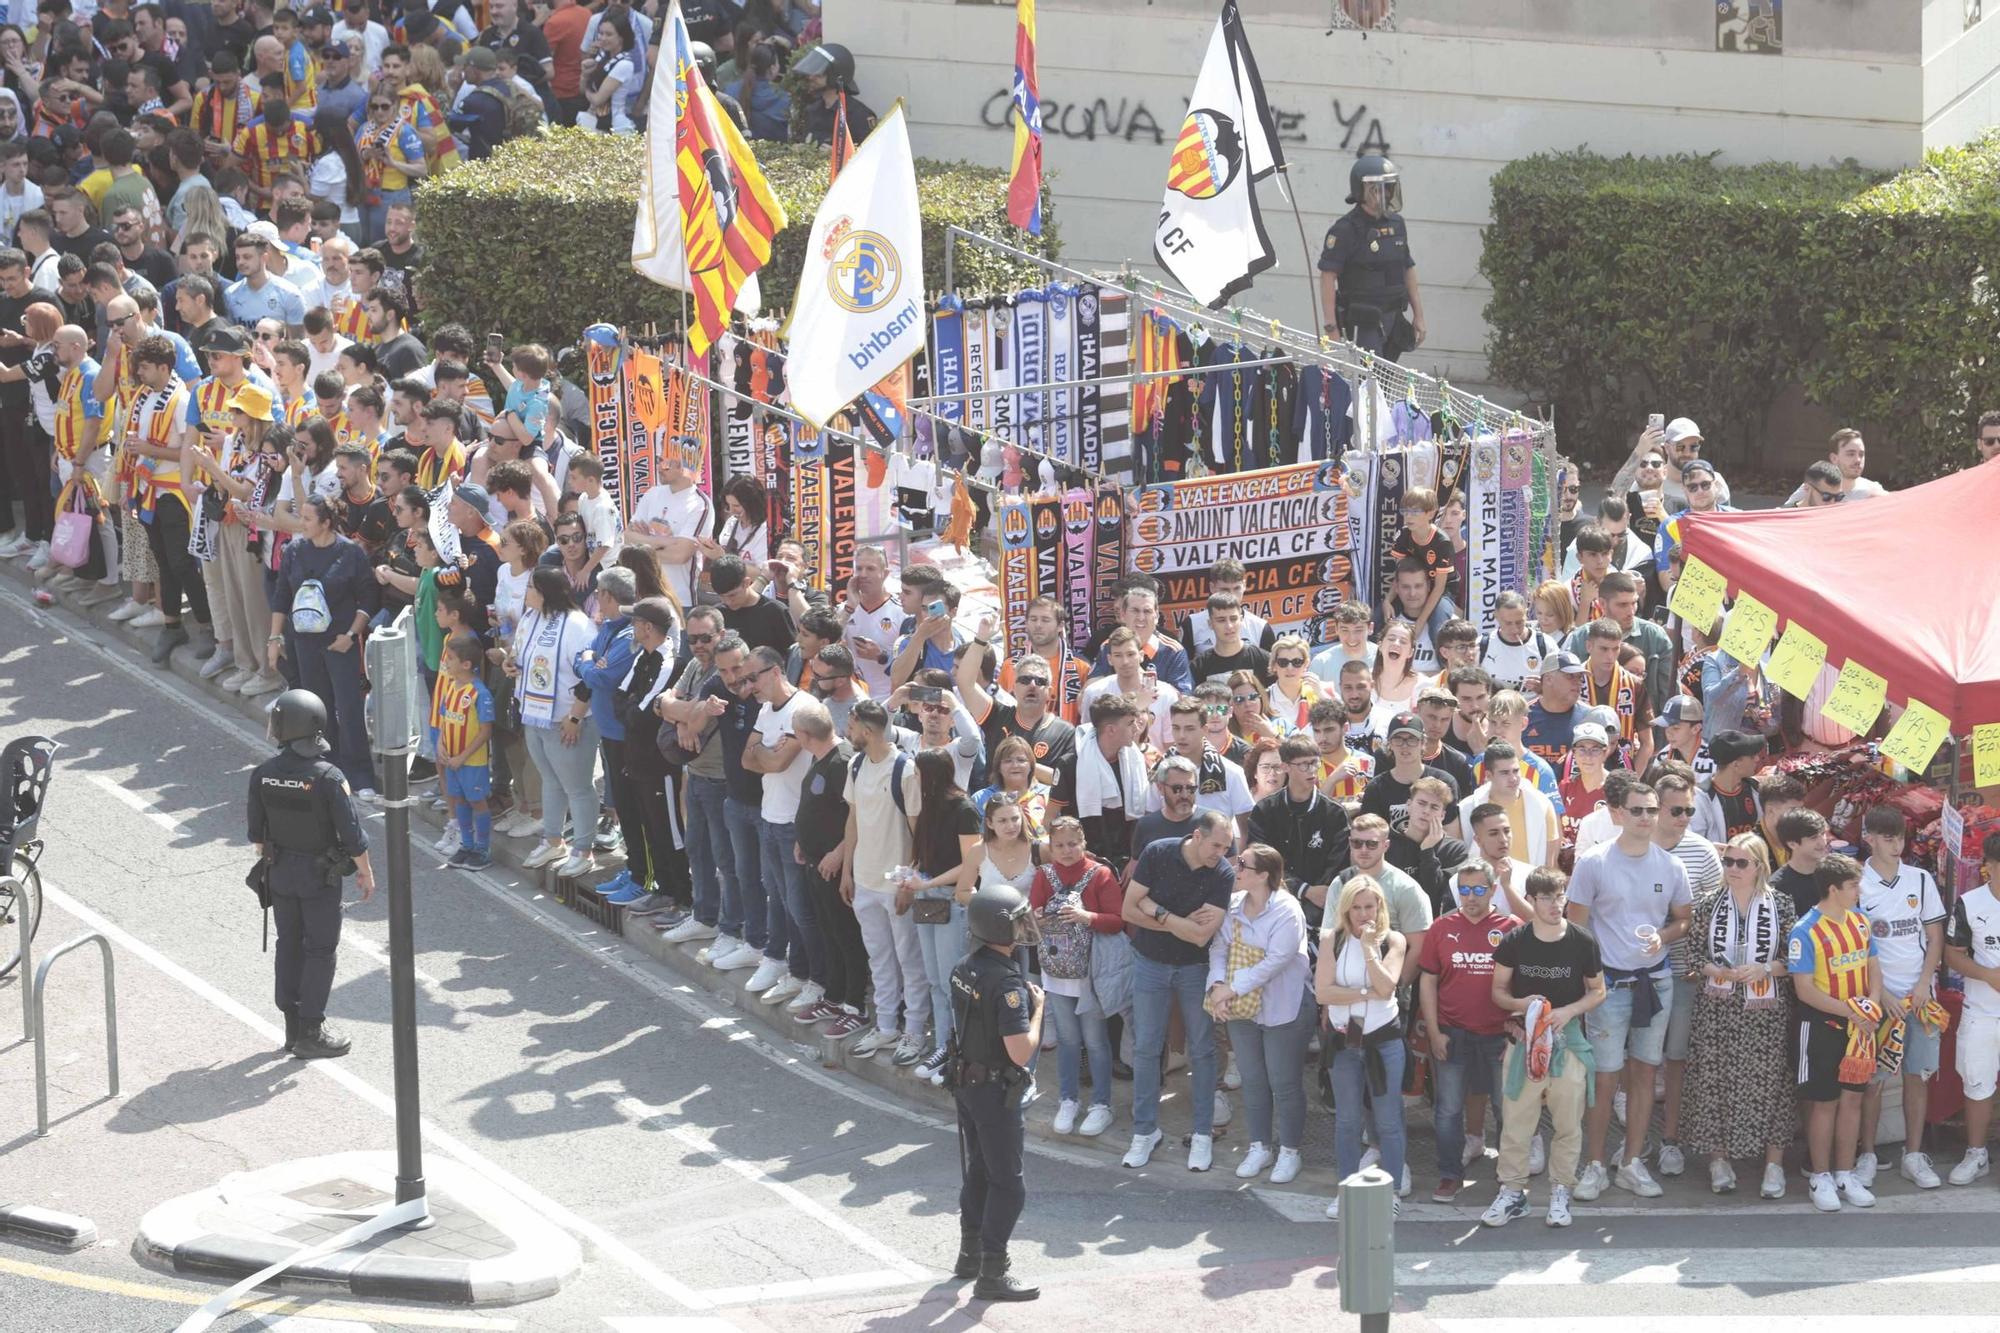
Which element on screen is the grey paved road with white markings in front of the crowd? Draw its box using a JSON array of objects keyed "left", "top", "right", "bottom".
[{"left": 0, "top": 582, "right": 2000, "bottom": 1333}]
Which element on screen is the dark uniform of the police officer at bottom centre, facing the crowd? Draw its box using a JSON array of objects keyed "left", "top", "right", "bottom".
[{"left": 952, "top": 945, "right": 1034, "bottom": 1255}]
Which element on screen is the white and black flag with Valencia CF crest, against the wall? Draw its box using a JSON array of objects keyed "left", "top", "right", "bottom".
[{"left": 1152, "top": 0, "right": 1284, "bottom": 306}]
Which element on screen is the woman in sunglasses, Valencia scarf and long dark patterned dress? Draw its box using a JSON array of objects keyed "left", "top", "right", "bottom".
[{"left": 1684, "top": 833, "right": 1798, "bottom": 1199}]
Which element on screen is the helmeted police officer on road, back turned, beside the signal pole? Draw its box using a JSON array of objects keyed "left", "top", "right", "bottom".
[{"left": 250, "top": 691, "right": 374, "bottom": 1061}]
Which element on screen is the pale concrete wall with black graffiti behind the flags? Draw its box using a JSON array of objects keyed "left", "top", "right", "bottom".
[{"left": 826, "top": 0, "right": 2000, "bottom": 394}]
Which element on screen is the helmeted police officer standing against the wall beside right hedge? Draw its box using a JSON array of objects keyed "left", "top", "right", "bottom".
[{"left": 1320, "top": 152, "right": 1424, "bottom": 360}]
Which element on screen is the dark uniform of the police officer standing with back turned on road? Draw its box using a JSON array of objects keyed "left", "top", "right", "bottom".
[{"left": 250, "top": 747, "right": 368, "bottom": 1033}]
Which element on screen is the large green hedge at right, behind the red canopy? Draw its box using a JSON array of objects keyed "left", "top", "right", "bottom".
[{"left": 1480, "top": 136, "right": 2000, "bottom": 480}]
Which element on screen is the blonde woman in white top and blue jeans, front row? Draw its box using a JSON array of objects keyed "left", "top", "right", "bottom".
[{"left": 1312, "top": 875, "right": 1408, "bottom": 1217}]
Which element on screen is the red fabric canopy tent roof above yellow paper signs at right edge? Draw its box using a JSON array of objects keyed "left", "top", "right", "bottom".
[{"left": 1680, "top": 464, "right": 2000, "bottom": 737}]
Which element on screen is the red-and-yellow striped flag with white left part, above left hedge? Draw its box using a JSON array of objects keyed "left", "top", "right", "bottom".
[{"left": 632, "top": 0, "right": 786, "bottom": 356}]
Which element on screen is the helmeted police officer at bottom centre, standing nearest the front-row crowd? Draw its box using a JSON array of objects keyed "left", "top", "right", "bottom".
[{"left": 946, "top": 885, "right": 1042, "bottom": 1301}]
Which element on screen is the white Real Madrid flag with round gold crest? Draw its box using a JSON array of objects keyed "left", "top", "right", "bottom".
[{"left": 786, "top": 102, "right": 926, "bottom": 426}]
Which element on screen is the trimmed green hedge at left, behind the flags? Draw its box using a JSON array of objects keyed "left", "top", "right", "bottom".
[{"left": 416, "top": 130, "right": 1056, "bottom": 346}]
